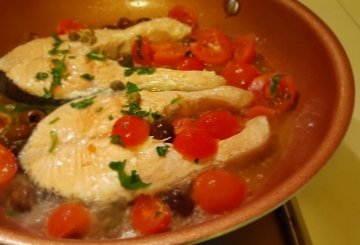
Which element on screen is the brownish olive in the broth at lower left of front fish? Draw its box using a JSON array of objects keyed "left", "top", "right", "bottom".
[{"left": 9, "top": 185, "right": 37, "bottom": 212}]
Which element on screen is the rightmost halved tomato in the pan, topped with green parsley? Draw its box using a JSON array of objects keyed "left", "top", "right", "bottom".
[{"left": 248, "top": 73, "right": 297, "bottom": 113}]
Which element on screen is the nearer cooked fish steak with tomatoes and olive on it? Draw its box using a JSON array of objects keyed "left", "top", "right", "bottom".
[{"left": 19, "top": 86, "right": 270, "bottom": 203}]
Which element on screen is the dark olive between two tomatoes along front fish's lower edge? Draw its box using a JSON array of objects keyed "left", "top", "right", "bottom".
[{"left": 163, "top": 188, "right": 195, "bottom": 217}]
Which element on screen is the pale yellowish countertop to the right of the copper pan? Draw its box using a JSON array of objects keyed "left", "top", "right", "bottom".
[{"left": 296, "top": 0, "right": 360, "bottom": 245}]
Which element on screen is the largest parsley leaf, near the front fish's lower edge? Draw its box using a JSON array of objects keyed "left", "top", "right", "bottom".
[{"left": 109, "top": 160, "right": 150, "bottom": 190}]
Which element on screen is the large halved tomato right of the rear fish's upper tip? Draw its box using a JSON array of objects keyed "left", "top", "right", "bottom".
[{"left": 190, "top": 29, "right": 232, "bottom": 65}]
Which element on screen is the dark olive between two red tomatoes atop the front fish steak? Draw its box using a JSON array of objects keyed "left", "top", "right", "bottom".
[{"left": 150, "top": 118, "right": 175, "bottom": 142}]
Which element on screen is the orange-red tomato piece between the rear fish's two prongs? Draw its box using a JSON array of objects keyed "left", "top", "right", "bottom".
[{"left": 151, "top": 42, "right": 189, "bottom": 66}]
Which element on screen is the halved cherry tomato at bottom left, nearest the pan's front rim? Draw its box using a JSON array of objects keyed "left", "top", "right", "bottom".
[{"left": 46, "top": 203, "right": 91, "bottom": 238}]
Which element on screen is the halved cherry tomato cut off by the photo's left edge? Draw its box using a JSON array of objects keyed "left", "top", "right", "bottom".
[{"left": 0, "top": 143, "right": 18, "bottom": 187}]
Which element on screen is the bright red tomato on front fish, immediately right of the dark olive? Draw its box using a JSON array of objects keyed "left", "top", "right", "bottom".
[{"left": 173, "top": 127, "right": 218, "bottom": 160}]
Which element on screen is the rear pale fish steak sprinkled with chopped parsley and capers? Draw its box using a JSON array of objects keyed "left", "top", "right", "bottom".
[{"left": 0, "top": 18, "right": 225, "bottom": 100}]
